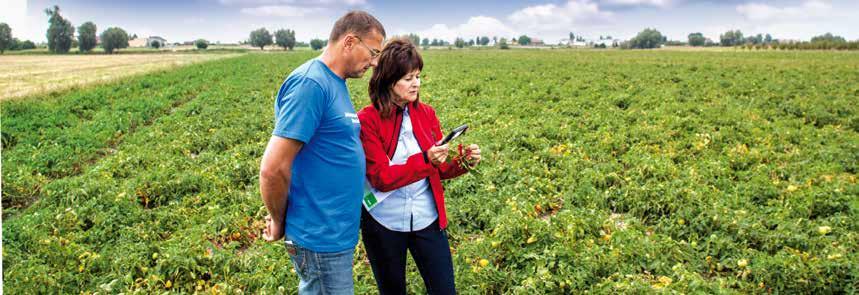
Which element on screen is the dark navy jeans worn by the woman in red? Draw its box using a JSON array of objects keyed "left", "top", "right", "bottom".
[{"left": 361, "top": 207, "right": 456, "bottom": 294}]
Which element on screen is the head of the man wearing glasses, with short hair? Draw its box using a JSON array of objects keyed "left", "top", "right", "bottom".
[{"left": 328, "top": 11, "right": 385, "bottom": 78}]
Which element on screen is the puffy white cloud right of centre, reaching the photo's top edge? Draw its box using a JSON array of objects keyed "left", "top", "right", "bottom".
[{"left": 508, "top": 0, "right": 614, "bottom": 32}]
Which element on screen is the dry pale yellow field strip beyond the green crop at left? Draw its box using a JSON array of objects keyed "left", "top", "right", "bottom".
[{"left": 0, "top": 54, "right": 236, "bottom": 100}]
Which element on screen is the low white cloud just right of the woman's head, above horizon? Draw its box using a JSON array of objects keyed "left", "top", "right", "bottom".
[{"left": 417, "top": 16, "right": 516, "bottom": 42}]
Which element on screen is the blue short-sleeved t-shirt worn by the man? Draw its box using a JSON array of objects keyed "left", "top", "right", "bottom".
[{"left": 272, "top": 59, "right": 366, "bottom": 252}]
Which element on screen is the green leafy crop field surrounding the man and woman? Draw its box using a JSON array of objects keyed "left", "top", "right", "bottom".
[{"left": 0, "top": 50, "right": 859, "bottom": 294}]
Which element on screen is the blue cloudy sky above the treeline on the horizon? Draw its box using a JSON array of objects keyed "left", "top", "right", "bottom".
[{"left": 0, "top": 0, "right": 859, "bottom": 44}]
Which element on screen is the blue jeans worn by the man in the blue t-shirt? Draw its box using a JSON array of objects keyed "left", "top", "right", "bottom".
[{"left": 287, "top": 245, "right": 355, "bottom": 295}]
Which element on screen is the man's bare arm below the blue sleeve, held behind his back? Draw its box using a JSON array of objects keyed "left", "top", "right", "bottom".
[{"left": 259, "top": 136, "right": 304, "bottom": 241}]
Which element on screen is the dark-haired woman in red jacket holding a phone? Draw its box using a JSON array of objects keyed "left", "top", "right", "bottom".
[{"left": 358, "top": 39, "right": 480, "bottom": 294}]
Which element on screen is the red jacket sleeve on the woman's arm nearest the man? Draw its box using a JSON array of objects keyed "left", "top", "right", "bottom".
[{"left": 359, "top": 112, "right": 434, "bottom": 192}]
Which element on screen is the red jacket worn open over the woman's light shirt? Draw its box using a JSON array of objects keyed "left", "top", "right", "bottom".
[{"left": 358, "top": 101, "right": 468, "bottom": 229}]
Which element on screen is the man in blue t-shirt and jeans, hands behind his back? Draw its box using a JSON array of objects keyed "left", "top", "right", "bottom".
[{"left": 260, "top": 11, "right": 385, "bottom": 294}]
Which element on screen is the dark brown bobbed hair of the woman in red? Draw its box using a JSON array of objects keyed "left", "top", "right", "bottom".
[{"left": 367, "top": 38, "right": 424, "bottom": 117}]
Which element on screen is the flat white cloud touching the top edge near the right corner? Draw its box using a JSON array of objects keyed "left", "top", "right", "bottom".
[{"left": 737, "top": 0, "right": 832, "bottom": 22}]
